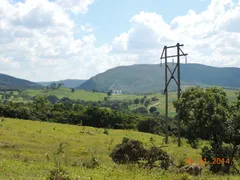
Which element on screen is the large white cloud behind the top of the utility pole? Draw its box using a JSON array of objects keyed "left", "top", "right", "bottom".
[{"left": 112, "top": 0, "right": 240, "bottom": 67}]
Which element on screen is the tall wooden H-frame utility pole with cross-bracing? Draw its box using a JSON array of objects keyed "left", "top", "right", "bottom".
[{"left": 160, "top": 43, "right": 188, "bottom": 146}]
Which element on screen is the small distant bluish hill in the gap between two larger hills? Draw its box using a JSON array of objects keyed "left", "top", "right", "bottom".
[{"left": 37, "top": 79, "right": 86, "bottom": 88}]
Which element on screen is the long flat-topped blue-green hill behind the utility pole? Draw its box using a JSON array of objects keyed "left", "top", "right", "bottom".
[{"left": 77, "top": 64, "right": 240, "bottom": 93}]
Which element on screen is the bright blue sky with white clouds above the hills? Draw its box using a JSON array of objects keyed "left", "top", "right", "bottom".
[{"left": 0, "top": 0, "right": 240, "bottom": 82}]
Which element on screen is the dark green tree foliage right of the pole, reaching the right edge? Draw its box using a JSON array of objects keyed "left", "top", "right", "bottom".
[{"left": 174, "top": 87, "right": 240, "bottom": 173}]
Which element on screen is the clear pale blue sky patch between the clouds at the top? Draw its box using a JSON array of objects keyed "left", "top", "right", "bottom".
[{"left": 72, "top": 0, "right": 210, "bottom": 45}]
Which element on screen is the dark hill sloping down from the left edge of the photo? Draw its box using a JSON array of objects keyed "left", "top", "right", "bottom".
[{"left": 0, "top": 74, "right": 43, "bottom": 89}]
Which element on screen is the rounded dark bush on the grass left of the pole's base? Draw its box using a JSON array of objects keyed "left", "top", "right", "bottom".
[{"left": 110, "top": 138, "right": 146, "bottom": 164}]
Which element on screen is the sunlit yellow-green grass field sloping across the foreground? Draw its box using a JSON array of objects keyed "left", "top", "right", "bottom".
[{"left": 0, "top": 118, "right": 238, "bottom": 180}]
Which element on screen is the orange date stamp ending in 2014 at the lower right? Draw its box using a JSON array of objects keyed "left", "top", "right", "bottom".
[{"left": 185, "top": 158, "right": 230, "bottom": 165}]
